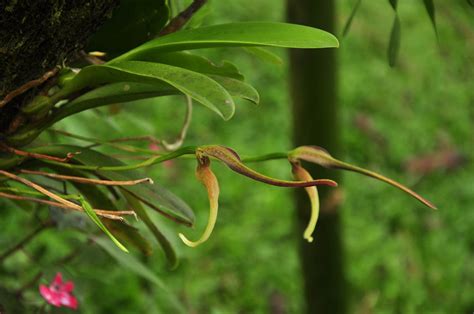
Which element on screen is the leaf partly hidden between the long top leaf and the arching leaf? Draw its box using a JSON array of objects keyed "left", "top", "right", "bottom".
[{"left": 134, "top": 51, "right": 244, "bottom": 80}]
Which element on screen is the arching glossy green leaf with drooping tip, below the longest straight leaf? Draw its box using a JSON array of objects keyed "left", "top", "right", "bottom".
[{"left": 59, "top": 61, "right": 235, "bottom": 120}]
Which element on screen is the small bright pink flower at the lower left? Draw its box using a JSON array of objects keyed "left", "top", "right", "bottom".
[{"left": 39, "top": 273, "right": 77, "bottom": 310}]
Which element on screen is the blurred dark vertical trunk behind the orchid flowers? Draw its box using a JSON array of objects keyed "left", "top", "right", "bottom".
[{"left": 287, "top": 0, "right": 346, "bottom": 314}]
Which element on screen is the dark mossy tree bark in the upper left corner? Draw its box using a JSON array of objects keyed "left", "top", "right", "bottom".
[{"left": 0, "top": 0, "right": 119, "bottom": 136}]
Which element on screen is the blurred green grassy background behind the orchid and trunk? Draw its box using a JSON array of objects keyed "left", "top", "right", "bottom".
[{"left": 0, "top": 0, "right": 474, "bottom": 313}]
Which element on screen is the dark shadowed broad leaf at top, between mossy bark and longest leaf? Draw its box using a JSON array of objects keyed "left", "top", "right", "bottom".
[{"left": 87, "top": 0, "right": 170, "bottom": 57}]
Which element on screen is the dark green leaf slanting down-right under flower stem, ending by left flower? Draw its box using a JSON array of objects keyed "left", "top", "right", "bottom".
[{"left": 31, "top": 145, "right": 194, "bottom": 226}]
